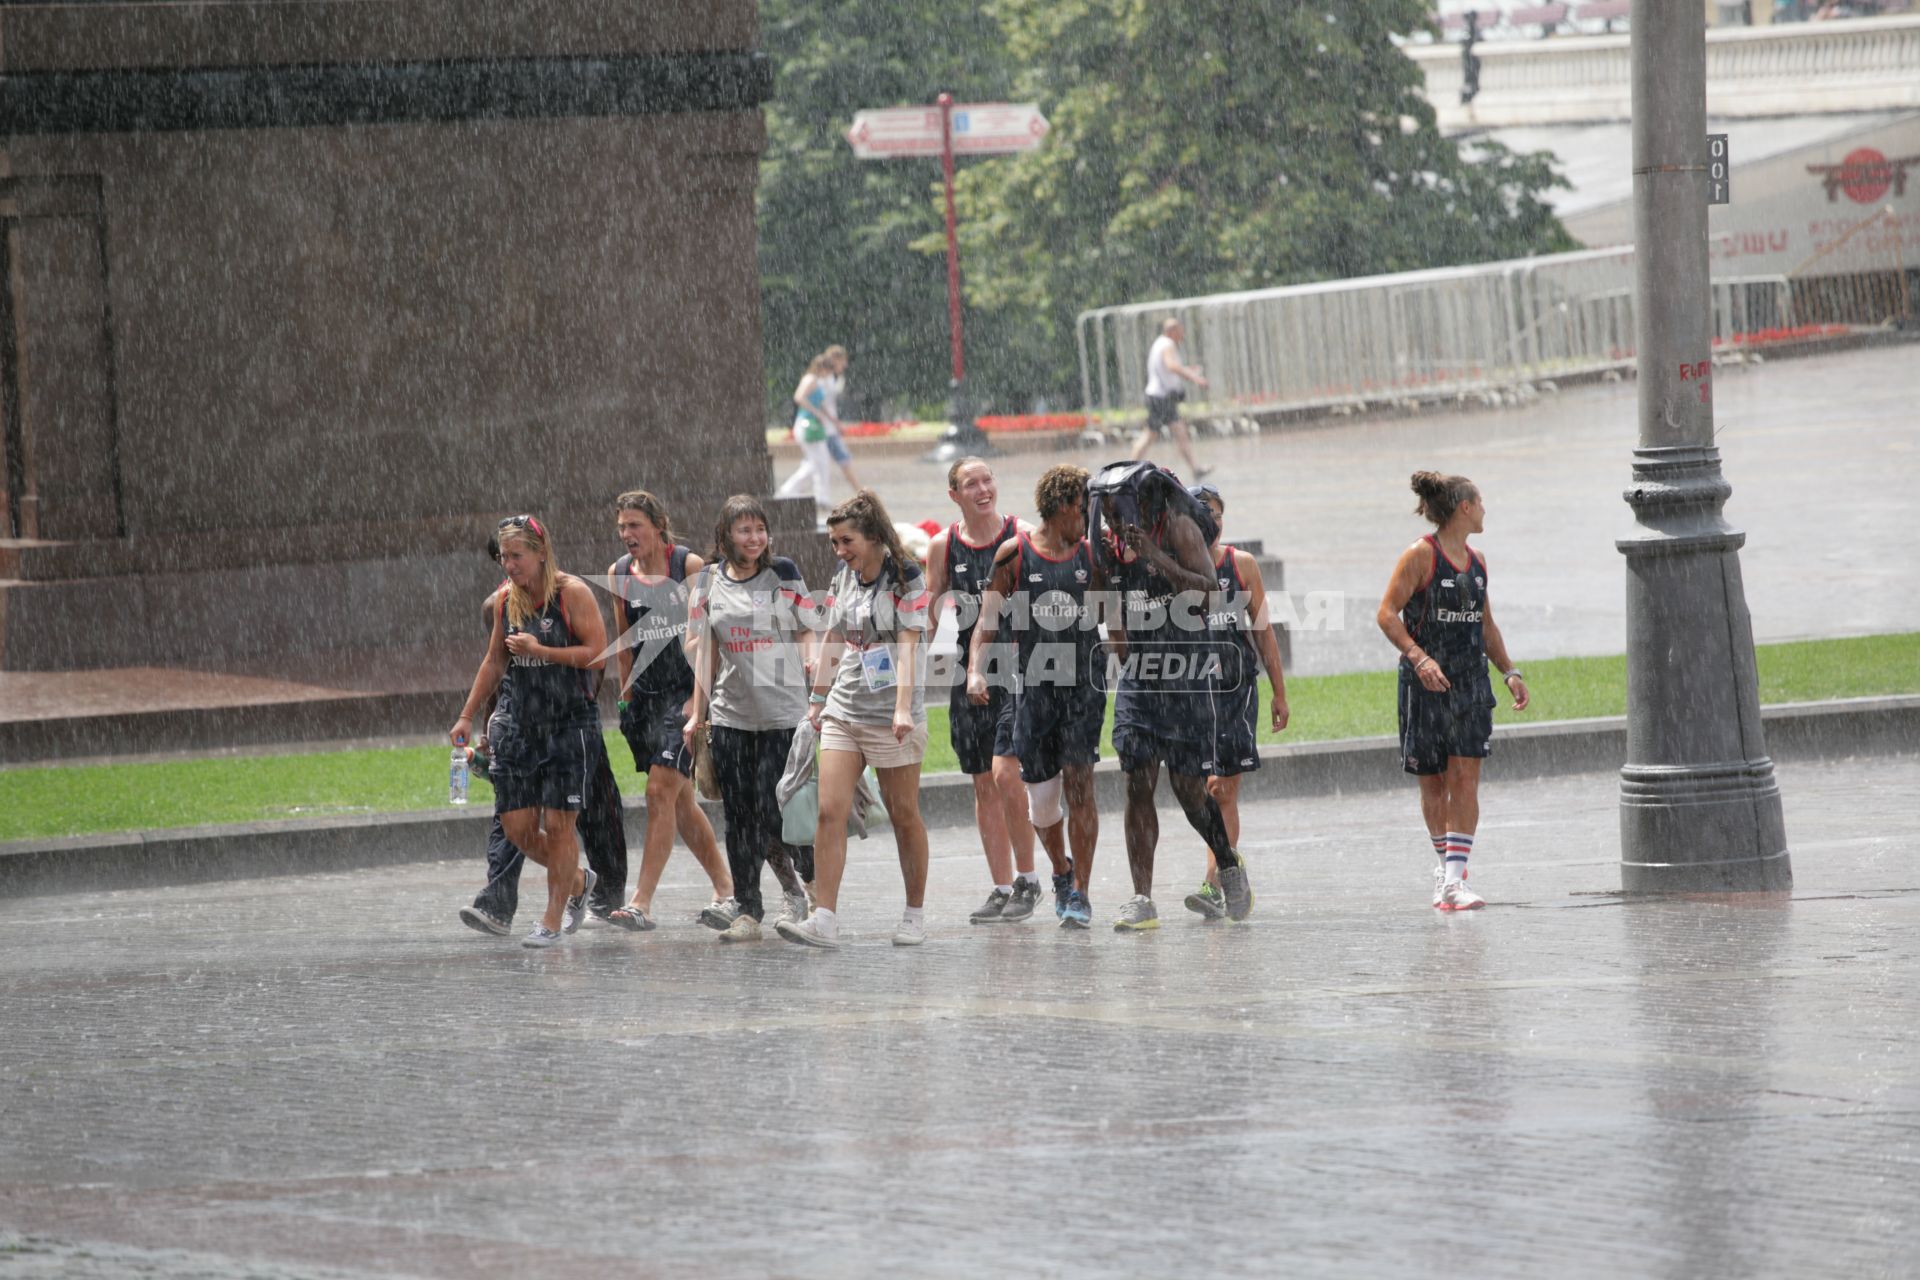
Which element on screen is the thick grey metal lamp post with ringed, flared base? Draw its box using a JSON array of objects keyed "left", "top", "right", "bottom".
[{"left": 1619, "top": 0, "right": 1793, "bottom": 892}]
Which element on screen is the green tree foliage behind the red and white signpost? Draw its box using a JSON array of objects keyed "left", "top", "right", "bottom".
[{"left": 760, "top": 0, "right": 1572, "bottom": 418}]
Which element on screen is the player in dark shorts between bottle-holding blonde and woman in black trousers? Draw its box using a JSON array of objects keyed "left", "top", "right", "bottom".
[{"left": 607, "top": 489, "right": 733, "bottom": 931}]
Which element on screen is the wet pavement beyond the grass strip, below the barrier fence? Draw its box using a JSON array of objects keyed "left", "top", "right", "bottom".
[{"left": 860, "top": 345, "right": 1920, "bottom": 676}]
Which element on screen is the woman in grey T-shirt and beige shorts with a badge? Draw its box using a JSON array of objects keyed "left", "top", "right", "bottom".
[{"left": 778, "top": 489, "right": 931, "bottom": 948}]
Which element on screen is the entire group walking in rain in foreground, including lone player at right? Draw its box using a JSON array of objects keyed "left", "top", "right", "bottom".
[{"left": 449, "top": 450, "right": 1526, "bottom": 948}]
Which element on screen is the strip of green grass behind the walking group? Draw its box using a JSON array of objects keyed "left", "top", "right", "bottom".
[{"left": 0, "top": 633, "right": 1920, "bottom": 841}]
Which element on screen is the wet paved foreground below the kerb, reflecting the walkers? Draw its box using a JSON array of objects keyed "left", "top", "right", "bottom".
[{"left": 0, "top": 756, "right": 1920, "bottom": 1280}]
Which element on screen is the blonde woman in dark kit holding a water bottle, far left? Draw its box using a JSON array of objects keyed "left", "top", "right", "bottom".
[{"left": 447, "top": 516, "right": 607, "bottom": 946}]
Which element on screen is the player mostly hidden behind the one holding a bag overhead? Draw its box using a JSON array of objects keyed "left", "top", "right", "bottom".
[{"left": 1187, "top": 484, "right": 1290, "bottom": 919}]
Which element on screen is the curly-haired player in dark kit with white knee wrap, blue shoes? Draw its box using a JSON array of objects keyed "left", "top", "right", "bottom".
[{"left": 966, "top": 464, "right": 1106, "bottom": 929}]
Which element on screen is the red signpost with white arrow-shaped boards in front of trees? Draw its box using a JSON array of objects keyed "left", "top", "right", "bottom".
[{"left": 847, "top": 94, "right": 1048, "bottom": 435}]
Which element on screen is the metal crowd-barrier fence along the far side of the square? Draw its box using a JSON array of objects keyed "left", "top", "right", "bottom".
[{"left": 1077, "top": 249, "right": 1793, "bottom": 416}]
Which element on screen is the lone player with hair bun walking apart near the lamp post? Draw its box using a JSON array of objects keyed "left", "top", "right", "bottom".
[{"left": 1375, "top": 470, "right": 1530, "bottom": 912}]
